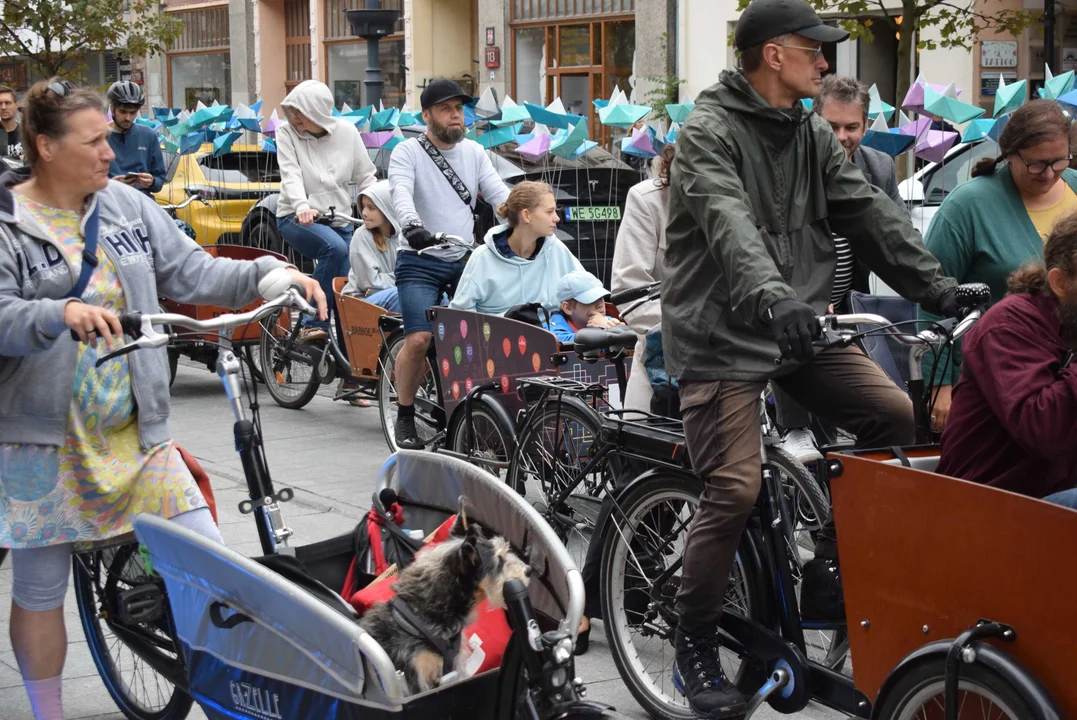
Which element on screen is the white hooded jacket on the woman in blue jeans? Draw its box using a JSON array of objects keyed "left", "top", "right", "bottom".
[{"left": 277, "top": 80, "right": 375, "bottom": 225}]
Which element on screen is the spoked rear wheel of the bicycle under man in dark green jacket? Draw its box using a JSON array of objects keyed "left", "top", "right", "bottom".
[{"left": 600, "top": 474, "right": 767, "bottom": 720}]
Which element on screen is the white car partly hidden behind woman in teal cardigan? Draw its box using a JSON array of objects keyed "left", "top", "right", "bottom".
[{"left": 870, "top": 140, "right": 998, "bottom": 295}]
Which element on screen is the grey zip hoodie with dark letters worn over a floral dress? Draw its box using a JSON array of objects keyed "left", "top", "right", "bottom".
[{"left": 0, "top": 171, "right": 284, "bottom": 449}]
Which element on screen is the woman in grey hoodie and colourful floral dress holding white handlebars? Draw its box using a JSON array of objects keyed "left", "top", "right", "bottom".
[{"left": 0, "top": 79, "right": 325, "bottom": 720}]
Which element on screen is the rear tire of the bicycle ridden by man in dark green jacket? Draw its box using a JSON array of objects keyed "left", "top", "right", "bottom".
[{"left": 600, "top": 472, "right": 769, "bottom": 720}]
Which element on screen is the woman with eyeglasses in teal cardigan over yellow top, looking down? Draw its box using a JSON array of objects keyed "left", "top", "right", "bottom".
[{"left": 920, "top": 100, "right": 1077, "bottom": 432}]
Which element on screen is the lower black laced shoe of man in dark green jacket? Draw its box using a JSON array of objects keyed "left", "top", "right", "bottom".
[{"left": 673, "top": 627, "right": 747, "bottom": 719}]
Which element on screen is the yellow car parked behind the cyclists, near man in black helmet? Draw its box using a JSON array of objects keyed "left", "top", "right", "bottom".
[{"left": 154, "top": 143, "right": 280, "bottom": 245}]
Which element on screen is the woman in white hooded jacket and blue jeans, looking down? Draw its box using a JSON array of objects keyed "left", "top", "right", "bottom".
[{"left": 277, "top": 80, "right": 375, "bottom": 349}]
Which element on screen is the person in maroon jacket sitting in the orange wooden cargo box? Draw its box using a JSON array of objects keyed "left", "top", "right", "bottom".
[{"left": 937, "top": 214, "right": 1077, "bottom": 509}]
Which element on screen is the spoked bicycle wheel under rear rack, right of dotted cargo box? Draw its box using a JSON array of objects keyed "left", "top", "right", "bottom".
[{"left": 505, "top": 396, "right": 610, "bottom": 567}]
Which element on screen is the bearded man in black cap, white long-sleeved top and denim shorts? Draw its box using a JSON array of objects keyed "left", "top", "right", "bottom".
[{"left": 389, "top": 80, "right": 508, "bottom": 449}]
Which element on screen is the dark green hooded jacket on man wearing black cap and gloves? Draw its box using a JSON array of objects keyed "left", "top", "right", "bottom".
[{"left": 662, "top": 71, "right": 956, "bottom": 382}]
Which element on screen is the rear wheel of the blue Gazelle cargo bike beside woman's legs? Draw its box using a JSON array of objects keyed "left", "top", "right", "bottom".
[{"left": 73, "top": 542, "right": 194, "bottom": 720}]
